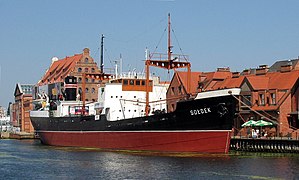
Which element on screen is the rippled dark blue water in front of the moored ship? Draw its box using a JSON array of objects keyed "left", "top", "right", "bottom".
[{"left": 0, "top": 140, "right": 299, "bottom": 179}]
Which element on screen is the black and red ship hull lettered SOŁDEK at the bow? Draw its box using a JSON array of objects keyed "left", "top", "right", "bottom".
[{"left": 31, "top": 91, "right": 236, "bottom": 153}]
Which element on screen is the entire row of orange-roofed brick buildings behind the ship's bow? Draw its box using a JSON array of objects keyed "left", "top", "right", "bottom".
[{"left": 167, "top": 59, "right": 299, "bottom": 136}]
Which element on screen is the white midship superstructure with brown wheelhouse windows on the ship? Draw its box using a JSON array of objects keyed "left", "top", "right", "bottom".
[{"left": 98, "top": 74, "right": 169, "bottom": 121}]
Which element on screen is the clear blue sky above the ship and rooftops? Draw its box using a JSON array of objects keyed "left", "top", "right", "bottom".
[{"left": 0, "top": 0, "right": 299, "bottom": 107}]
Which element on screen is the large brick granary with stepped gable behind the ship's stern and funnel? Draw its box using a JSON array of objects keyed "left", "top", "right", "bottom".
[{"left": 35, "top": 48, "right": 100, "bottom": 101}]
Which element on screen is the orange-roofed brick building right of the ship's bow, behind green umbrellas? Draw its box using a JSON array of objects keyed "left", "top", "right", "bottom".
[{"left": 215, "top": 63, "right": 299, "bottom": 136}]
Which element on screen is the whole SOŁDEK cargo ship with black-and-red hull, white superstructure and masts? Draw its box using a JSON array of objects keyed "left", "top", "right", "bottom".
[{"left": 30, "top": 16, "right": 240, "bottom": 153}]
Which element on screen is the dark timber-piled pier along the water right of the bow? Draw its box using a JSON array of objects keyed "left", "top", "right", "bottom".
[{"left": 230, "top": 137, "right": 299, "bottom": 153}]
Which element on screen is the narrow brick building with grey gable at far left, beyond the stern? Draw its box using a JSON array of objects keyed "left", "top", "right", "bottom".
[{"left": 10, "top": 83, "right": 34, "bottom": 133}]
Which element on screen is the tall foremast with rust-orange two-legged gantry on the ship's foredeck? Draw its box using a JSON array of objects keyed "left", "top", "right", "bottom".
[{"left": 145, "top": 13, "right": 191, "bottom": 116}]
